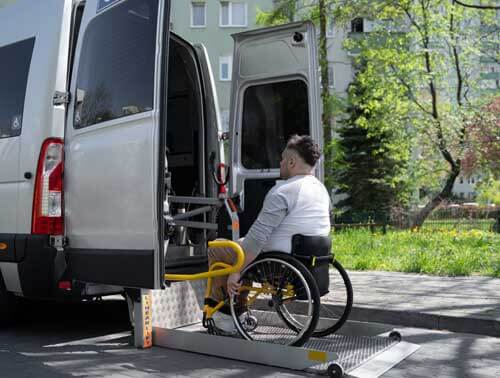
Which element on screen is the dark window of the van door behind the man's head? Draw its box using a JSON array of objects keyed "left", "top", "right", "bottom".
[{"left": 241, "top": 80, "right": 309, "bottom": 169}]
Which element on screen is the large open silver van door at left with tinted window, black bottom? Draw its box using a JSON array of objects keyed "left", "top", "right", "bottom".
[{"left": 64, "top": 0, "right": 170, "bottom": 288}]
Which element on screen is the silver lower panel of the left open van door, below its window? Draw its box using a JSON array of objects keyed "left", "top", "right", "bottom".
[{"left": 65, "top": 112, "right": 156, "bottom": 250}]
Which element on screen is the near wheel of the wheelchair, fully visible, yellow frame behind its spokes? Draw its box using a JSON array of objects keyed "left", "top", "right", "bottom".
[{"left": 230, "top": 252, "right": 320, "bottom": 346}]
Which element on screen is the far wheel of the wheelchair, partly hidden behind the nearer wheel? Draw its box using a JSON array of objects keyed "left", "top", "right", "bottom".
[{"left": 278, "top": 260, "right": 353, "bottom": 337}]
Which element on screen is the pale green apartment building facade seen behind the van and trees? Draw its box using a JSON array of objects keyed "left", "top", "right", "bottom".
[{"left": 0, "top": 0, "right": 494, "bottom": 200}]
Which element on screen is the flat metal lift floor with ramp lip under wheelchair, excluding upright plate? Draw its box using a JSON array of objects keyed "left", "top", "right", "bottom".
[{"left": 154, "top": 323, "right": 419, "bottom": 378}]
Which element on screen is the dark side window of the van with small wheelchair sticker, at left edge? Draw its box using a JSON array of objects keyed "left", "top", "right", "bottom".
[{"left": 0, "top": 38, "right": 35, "bottom": 139}]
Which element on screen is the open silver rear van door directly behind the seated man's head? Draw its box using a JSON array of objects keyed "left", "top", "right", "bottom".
[{"left": 230, "top": 22, "right": 323, "bottom": 235}]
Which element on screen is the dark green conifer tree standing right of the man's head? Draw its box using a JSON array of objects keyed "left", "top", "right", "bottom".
[{"left": 333, "top": 63, "right": 410, "bottom": 213}]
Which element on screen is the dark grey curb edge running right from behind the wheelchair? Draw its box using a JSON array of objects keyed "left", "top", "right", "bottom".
[{"left": 327, "top": 305, "right": 500, "bottom": 337}]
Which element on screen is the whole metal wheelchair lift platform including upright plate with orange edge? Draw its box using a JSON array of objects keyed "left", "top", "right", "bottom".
[{"left": 134, "top": 280, "right": 419, "bottom": 378}]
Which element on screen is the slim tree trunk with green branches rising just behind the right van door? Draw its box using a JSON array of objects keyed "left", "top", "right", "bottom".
[{"left": 257, "top": 0, "right": 335, "bottom": 192}]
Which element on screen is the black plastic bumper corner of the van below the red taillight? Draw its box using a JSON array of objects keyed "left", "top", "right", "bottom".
[{"left": 0, "top": 234, "right": 57, "bottom": 298}]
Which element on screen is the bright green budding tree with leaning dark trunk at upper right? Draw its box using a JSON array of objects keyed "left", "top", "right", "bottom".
[{"left": 335, "top": 0, "right": 498, "bottom": 226}]
